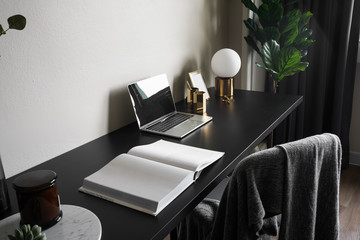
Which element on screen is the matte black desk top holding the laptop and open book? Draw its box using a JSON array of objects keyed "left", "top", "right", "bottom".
[{"left": 1, "top": 89, "right": 302, "bottom": 240}]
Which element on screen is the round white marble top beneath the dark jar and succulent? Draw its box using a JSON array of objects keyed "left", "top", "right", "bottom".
[{"left": 0, "top": 205, "right": 101, "bottom": 240}]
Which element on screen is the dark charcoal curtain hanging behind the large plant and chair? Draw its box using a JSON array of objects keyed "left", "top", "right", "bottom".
[{"left": 267, "top": 0, "right": 360, "bottom": 168}]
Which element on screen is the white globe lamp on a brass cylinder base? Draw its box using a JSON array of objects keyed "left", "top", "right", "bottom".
[{"left": 211, "top": 48, "right": 241, "bottom": 98}]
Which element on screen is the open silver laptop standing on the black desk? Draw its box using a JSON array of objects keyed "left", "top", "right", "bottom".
[{"left": 128, "top": 74, "right": 212, "bottom": 138}]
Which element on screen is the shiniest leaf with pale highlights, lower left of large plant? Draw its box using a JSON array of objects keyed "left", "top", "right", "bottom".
[{"left": 261, "top": 40, "right": 280, "bottom": 72}]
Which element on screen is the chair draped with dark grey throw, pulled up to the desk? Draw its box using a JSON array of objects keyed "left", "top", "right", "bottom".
[{"left": 178, "top": 134, "right": 342, "bottom": 240}]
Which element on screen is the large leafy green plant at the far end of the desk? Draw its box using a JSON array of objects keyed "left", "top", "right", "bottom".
[{"left": 242, "top": 0, "right": 314, "bottom": 85}]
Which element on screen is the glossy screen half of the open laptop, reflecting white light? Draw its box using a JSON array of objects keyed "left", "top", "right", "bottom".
[{"left": 128, "top": 74, "right": 175, "bottom": 127}]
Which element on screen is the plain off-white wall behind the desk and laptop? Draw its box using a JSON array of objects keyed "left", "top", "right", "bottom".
[{"left": 0, "top": 0, "right": 227, "bottom": 177}]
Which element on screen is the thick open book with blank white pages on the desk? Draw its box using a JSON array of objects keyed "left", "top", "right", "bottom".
[{"left": 79, "top": 140, "right": 224, "bottom": 215}]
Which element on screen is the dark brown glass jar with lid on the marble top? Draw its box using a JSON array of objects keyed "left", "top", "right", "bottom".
[{"left": 13, "top": 170, "right": 62, "bottom": 229}]
